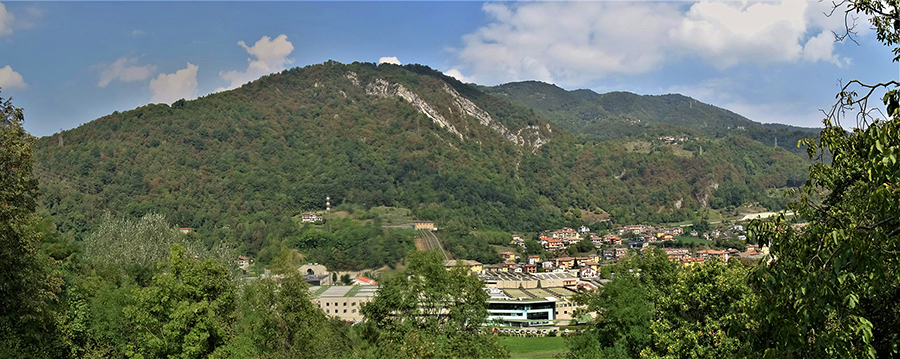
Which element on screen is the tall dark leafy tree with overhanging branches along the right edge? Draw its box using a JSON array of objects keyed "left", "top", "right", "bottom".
[{"left": 751, "top": 0, "right": 900, "bottom": 358}]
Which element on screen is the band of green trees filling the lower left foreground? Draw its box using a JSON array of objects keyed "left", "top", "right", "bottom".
[{"left": 0, "top": 215, "right": 440, "bottom": 358}]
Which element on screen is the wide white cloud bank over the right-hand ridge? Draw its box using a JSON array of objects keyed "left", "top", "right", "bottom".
[{"left": 450, "top": 0, "right": 847, "bottom": 86}]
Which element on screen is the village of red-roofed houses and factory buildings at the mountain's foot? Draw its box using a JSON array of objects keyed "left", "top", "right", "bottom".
[{"left": 236, "top": 218, "right": 768, "bottom": 333}]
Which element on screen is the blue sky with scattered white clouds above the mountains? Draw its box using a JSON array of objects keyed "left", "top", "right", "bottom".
[{"left": 0, "top": 0, "right": 900, "bottom": 136}]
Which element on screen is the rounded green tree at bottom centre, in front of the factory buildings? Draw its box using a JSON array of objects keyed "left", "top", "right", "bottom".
[{"left": 362, "top": 252, "right": 506, "bottom": 358}]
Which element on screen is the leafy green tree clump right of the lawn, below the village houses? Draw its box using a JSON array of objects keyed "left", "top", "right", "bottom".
[{"left": 566, "top": 250, "right": 753, "bottom": 358}]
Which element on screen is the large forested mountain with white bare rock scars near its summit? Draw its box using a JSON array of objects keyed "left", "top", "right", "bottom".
[{"left": 34, "top": 61, "right": 806, "bottom": 259}]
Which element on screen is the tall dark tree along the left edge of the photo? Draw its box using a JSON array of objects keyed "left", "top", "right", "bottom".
[{"left": 0, "top": 90, "right": 61, "bottom": 357}]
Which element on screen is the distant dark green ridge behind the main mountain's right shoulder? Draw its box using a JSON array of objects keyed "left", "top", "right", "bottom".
[{"left": 481, "top": 81, "right": 820, "bottom": 156}]
